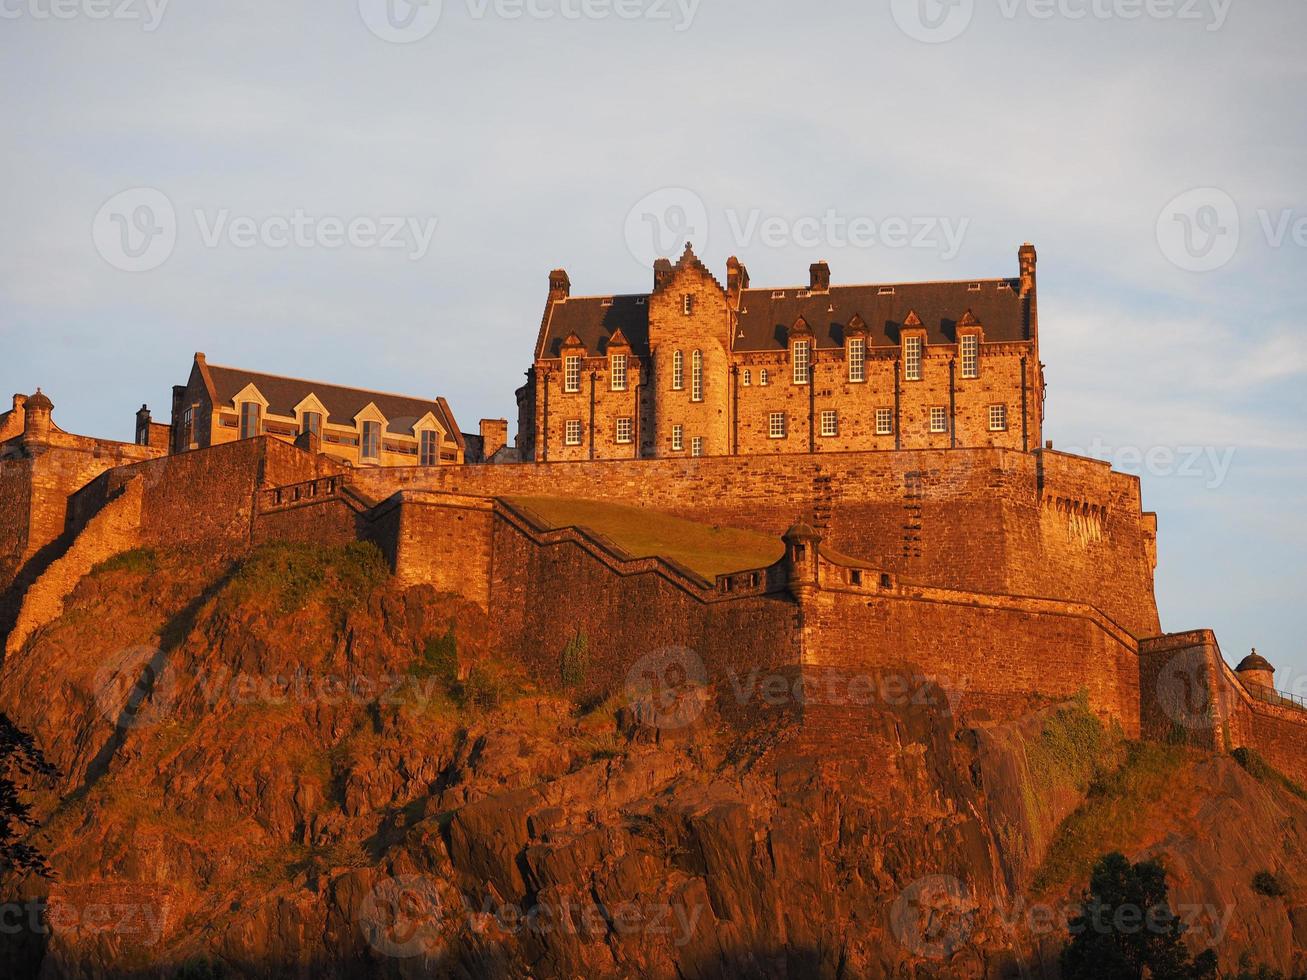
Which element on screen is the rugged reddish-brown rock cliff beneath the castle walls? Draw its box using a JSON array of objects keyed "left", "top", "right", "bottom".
[{"left": 0, "top": 549, "right": 1307, "bottom": 977}]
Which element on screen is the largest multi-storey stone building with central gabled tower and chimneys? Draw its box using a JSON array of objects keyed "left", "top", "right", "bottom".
[{"left": 518, "top": 244, "right": 1044, "bottom": 463}]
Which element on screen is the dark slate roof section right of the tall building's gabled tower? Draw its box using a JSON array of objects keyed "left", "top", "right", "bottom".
[{"left": 735, "top": 280, "right": 1030, "bottom": 350}]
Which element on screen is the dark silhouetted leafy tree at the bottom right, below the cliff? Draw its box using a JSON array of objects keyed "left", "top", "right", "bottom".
[{"left": 1061, "top": 853, "right": 1217, "bottom": 980}]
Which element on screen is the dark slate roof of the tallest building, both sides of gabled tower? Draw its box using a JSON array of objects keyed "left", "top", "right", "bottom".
[{"left": 536, "top": 280, "right": 1030, "bottom": 358}]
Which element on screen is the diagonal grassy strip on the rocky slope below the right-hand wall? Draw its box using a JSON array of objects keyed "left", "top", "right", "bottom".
[{"left": 1034, "top": 742, "right": 1191, "bottom": 894}]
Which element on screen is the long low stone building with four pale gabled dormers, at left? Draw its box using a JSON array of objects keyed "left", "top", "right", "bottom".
[{"left": 155, "top": 353, "right": 507, "bottom": 466}]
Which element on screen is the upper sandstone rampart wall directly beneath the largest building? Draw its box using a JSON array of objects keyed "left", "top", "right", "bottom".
[{"left": 349, "top": 449, "right": 1159, "bottom": 636}]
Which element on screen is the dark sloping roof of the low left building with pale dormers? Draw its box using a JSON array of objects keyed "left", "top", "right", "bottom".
[{"left": 198, "top": 365, "right": 459, "bottom": 439}]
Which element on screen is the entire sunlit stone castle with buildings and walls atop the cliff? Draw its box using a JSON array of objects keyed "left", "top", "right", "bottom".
[{"left": 0, "top": 246, "right": 1307, "bottom": 780}]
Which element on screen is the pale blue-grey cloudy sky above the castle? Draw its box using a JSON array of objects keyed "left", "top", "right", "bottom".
[{"left": 0, "top": 0, "right": 1307, "bottom": 695}]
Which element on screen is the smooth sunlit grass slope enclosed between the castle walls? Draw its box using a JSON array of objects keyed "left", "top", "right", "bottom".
[{"left": 506, "top": 497, "right": 784, "bottom": 580}]
